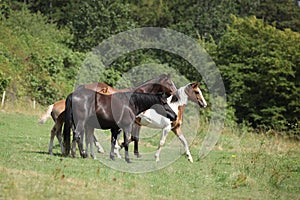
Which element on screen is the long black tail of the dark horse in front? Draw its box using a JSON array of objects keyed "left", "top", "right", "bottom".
[{"left": 63, "top": 93, "right": 73, "bottom": 156}]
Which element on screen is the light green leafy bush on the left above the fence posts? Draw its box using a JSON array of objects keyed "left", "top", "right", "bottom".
[{"left": 0, "top": 7, "right": 81, "bottom": 104}]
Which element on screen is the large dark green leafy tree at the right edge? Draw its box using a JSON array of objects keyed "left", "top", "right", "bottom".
[{"left": 216, "top": 17, "right": 300, "bottom": 129}]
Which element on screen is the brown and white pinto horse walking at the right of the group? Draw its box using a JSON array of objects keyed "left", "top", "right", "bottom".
[{"left": 129, "top": 83, "right": 207, "bottom": 162}]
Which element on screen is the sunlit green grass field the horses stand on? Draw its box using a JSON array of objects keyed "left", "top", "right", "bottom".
[{"left": 0, "top": 112, "right": 300, "bottom": 199}]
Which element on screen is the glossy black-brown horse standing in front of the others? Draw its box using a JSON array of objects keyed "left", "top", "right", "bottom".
[{"left": 64, "top": 87, "right": 177, "bottom": 163}]
